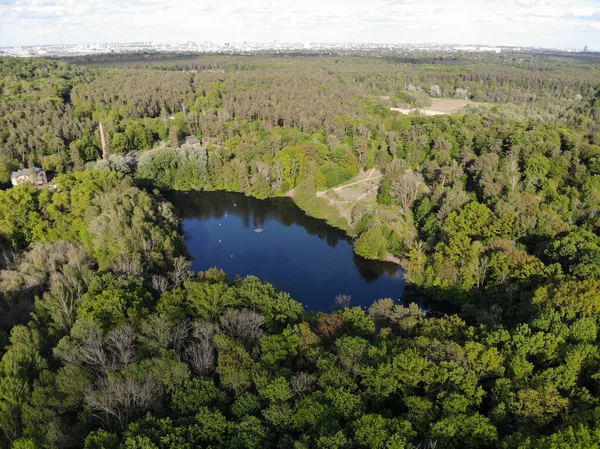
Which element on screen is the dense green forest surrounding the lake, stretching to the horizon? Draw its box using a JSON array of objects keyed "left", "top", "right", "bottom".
[{"left": 0, "top": 52, "right": 600, "bottom": 449}]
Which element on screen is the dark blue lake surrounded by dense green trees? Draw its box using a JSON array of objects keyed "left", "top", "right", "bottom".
[{"left": 169, "top": 192, "right": 404, "bottom": 311}]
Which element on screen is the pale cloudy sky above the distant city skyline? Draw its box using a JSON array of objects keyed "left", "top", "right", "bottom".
[{"left": 0, "top": 0, "right": 600, "bottom": 51}]
